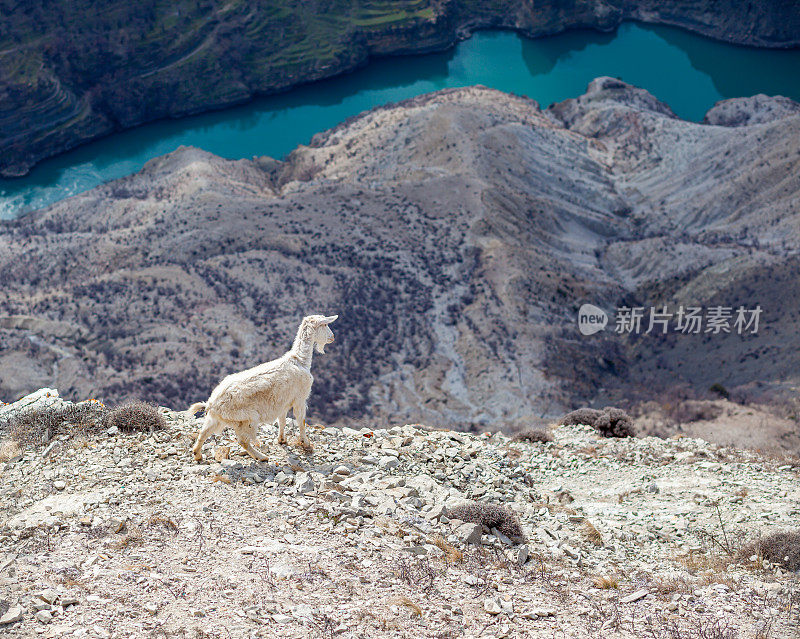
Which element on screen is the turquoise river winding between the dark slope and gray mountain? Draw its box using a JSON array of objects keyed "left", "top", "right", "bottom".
[{"left": 0, "top": 23, "right": 800, "bottom": 218}]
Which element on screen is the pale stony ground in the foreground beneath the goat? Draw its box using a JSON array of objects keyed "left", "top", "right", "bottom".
[{"left": 0, "top": 390, "right": 800, "bottom": 639}]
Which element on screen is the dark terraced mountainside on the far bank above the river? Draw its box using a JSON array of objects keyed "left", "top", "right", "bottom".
[{"left": 0, "top": 0, "right": 800, "bottom": 177}]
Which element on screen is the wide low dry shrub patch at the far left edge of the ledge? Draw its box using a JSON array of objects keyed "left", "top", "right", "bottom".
[{"left": 5, "top": 402, "right": 105, "bottom": 446}]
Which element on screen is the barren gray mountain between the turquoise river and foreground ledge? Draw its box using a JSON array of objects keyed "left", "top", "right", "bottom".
[{"left": 0, "top": 78, "right": 800, "bottom": 440}]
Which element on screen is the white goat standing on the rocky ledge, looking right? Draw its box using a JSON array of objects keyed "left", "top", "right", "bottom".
[{"left": 187, "top": 315, "right": 339, "bottom": 461}]
